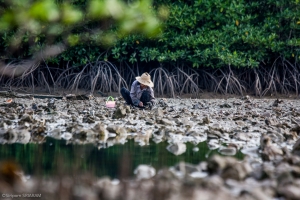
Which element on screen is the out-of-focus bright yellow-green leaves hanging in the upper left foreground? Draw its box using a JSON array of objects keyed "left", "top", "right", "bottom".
[{"left": 0, "top": 0, "right": 161, "bottom": 45}]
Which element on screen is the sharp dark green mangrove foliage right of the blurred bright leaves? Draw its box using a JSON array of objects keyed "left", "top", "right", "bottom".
[{"left": 112, "top": 0, "right": 300, "bottom": 68}]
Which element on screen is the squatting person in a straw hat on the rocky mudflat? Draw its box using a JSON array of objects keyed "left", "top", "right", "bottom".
[{"left": 121, "top": 72, "right": 155, "bottom": 109}]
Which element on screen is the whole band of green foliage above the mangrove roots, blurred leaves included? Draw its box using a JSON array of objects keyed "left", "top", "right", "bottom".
[{"left": 0, "top": 0, "right": 300, "bottom": 68}]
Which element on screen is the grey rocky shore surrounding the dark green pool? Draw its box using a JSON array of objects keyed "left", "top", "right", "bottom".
[{"left": 0, "top": 96, "right": 300, "bottom": 200}]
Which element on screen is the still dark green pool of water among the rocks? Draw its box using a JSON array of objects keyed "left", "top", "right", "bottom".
[{"left": 0, "top": 137, "right": 244, "bottom": 178}]
